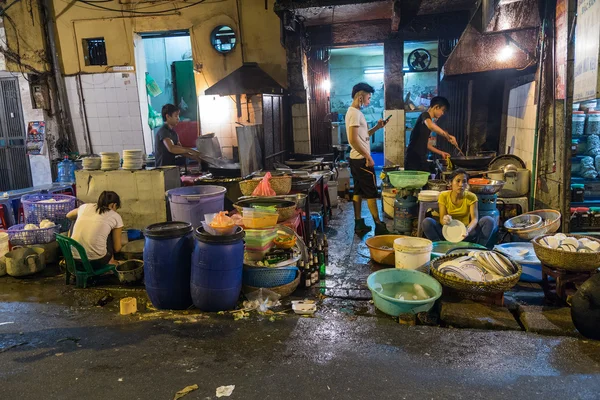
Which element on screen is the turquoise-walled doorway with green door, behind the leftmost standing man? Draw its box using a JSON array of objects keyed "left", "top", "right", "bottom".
[{"left": 135, "top": 30, "right": 198, "bottom": 154}]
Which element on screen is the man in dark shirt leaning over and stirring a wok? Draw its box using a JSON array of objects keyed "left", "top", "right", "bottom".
[{"left": 404, "top": 97, "right": 456, "bottom": 172}]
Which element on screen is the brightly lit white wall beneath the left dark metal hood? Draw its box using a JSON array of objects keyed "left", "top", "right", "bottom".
[{"left": 198, "top": 95, "right": 262, "bottom": 159}]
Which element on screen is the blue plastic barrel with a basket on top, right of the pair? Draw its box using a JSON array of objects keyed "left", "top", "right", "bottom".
[{"left": 190, "top": 227, "right": 246, "bottom": 312}]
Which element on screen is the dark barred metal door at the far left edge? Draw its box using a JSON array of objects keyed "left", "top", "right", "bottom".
[{"left": 0, "top": 77, "right": 32, "bottom": 192}]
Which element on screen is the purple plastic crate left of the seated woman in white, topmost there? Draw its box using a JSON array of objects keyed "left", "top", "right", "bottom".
[{"left": 21, "top": 194, "right": 77, "bottom": 229}]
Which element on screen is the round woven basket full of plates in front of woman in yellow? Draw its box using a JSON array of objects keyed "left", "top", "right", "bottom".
[{"left": 431, "top": 253, "right": 522, "bottom": 295}]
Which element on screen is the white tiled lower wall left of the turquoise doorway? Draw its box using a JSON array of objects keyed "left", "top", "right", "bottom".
[{"left": 65, "top": 73, "right": 144, "bottom": 154}]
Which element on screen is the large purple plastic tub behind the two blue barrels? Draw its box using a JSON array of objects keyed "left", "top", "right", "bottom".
[{"left": 167, "top": 185, "right": 227, "bottom": 228}]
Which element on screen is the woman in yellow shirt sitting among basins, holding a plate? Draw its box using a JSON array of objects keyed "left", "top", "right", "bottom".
[{"left": 423, "top": 169, "right": 498, "bottom": 247}]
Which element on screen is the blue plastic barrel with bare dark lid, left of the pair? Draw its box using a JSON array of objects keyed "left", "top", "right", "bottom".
[{"left": 144, "top": 222, "right": 194, "bottom": 310}]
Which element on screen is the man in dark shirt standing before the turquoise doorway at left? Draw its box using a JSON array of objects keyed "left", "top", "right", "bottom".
[{"left": 154, "top": 104, "right": 200, "bottom": 167}]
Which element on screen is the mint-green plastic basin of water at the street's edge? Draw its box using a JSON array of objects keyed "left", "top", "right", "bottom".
[{"left": 367, "top": 268, "right": 442, "bottom": 317}]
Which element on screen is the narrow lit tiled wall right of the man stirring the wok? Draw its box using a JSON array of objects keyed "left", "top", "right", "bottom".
[{"left": 506, "top": 82, "right": 537, "bottom": 169}]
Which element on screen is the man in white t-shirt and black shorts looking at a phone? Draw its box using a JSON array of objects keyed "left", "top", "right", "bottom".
[{"left": 346, "top": 83, "right": 389, "bottom": 235}]
